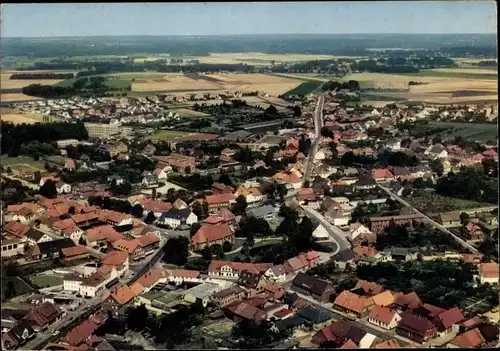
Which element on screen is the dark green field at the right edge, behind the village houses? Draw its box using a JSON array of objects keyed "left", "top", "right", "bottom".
[{"left": 427, "top": 122, "right": 498, "bottom": 141}]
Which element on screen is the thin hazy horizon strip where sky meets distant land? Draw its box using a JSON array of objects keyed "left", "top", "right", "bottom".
[{"left": 1, "top": 32, "right": 498, "bottom": 39}]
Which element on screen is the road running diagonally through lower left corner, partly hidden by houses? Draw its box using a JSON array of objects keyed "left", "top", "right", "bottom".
[{"left": 20, "top": 246, "right": 163, "bottom": 350}]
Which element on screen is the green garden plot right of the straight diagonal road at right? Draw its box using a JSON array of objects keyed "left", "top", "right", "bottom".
[{"left": 405, "top": 190, "right": 492, "bottom": 214}]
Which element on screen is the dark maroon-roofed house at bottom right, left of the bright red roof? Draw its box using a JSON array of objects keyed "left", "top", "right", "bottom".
[{"left": 396, "top": 311, "right": 437, "bottom": 344}]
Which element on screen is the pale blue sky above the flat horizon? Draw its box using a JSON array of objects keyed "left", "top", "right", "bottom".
[{"left": 0, "top": 0, "right": 497, "bottom": 37}]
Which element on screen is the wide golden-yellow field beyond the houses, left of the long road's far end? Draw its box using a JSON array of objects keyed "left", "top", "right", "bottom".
[{"left": 132, "top": 74, "right": 302, "bottom": 96}]
